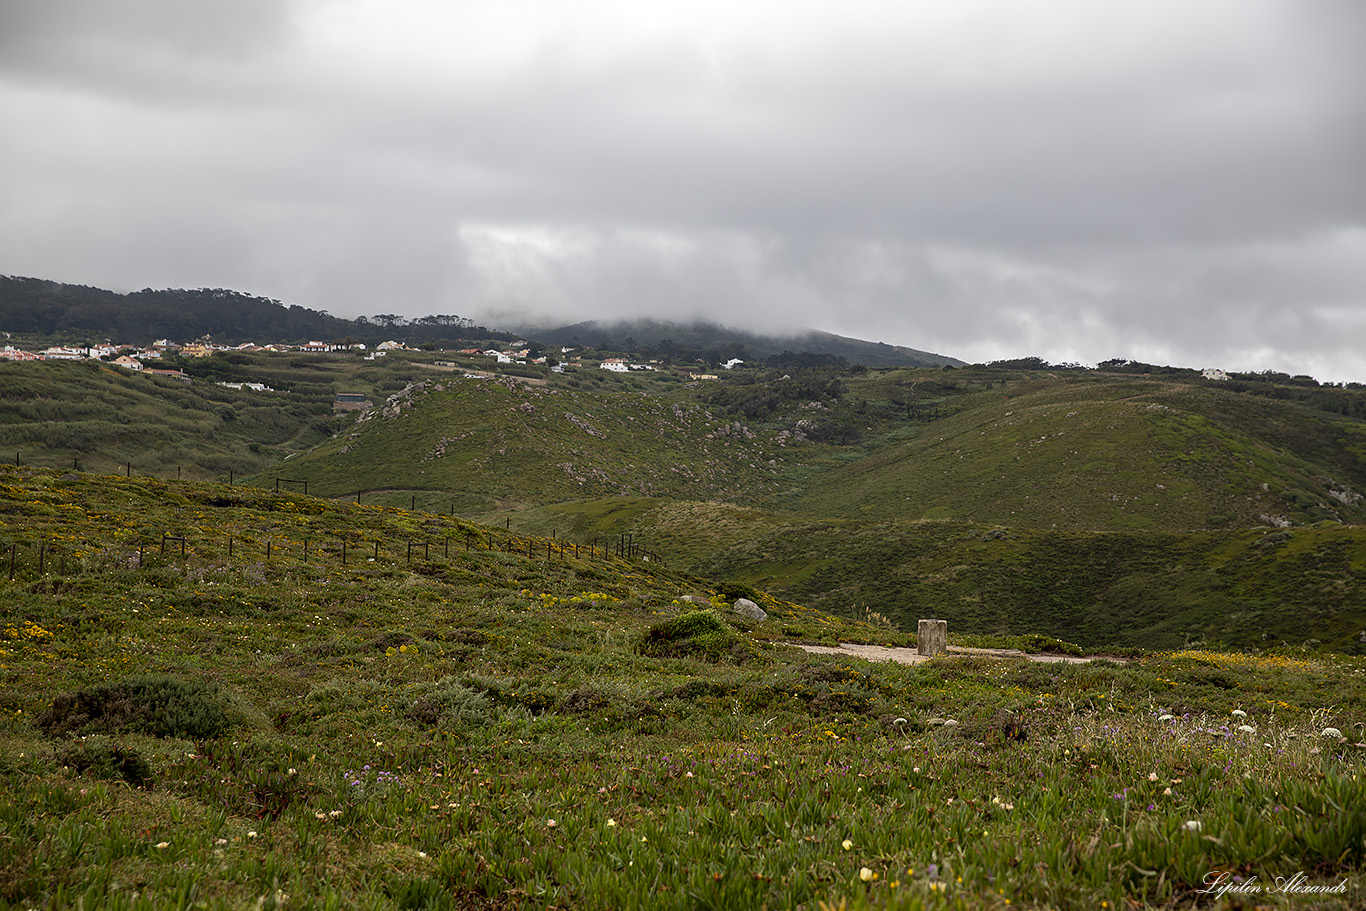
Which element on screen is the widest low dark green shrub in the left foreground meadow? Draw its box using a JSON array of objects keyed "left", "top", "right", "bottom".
[{"left": 37, "top": 675, "right": 232, "bottom": 740}]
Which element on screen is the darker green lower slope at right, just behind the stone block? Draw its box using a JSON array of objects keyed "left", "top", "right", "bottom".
[{"left": 697, "top": 522, "right": 1366, "bottom": 654}]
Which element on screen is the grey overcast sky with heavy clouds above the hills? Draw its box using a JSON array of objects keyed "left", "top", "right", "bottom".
[{"left": 0, "top": 0, "right": 1366, "bottom": 381}]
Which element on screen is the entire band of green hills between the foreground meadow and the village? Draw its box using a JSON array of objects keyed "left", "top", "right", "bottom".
[{"left": 0, "top": 354, "right": 1366, "bottom": 651}]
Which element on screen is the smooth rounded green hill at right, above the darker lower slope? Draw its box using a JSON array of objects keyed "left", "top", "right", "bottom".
[{"left": 787, "top": 376, "right": 1366, "bottom": 530}]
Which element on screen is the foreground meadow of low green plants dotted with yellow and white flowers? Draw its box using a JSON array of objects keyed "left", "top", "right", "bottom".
[{"left": 0, "top": 467, "right": 1366, "bottom": 910}]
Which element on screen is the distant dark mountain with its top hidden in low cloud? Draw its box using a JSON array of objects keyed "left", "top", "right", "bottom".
[{"left": 515, "top": 320, "right": 964, "bottom": 367}]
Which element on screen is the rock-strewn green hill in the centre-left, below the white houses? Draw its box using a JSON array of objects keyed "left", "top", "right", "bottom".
[{"left": 266, "top": 374, "right": 797, "bottom": 514}]
